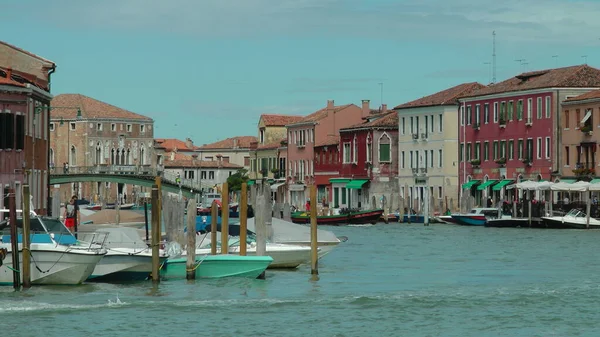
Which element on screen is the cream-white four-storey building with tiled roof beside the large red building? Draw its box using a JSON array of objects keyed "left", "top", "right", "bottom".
[{"left": 394, "top": 83, "right": 484, "bottom": 211}]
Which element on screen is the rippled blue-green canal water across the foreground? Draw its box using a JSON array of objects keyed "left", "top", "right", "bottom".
[{"left": 0, "top": 224, "right": 600, "bottom": 337}]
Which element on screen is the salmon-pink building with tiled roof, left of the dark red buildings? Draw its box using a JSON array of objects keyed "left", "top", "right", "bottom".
[{"left": 287, "top": 100, "right": 370, "bottom": 208}]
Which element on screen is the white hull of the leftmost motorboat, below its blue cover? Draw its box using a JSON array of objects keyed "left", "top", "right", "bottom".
[{"left": 0, "top": 244, "right": 104, "bottom": 285}]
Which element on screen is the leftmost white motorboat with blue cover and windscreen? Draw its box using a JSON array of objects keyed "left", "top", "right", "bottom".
[{"left": 0, "top": 216, "right": 106, "bottom": 285}]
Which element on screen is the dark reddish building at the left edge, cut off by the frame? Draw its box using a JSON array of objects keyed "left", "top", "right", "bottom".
[{"left": 0, "top": 41, "right": 56, "bottom": 215}]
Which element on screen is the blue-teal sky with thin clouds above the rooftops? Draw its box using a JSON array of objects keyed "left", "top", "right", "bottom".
[{"left": 0, "top": 0, "right": 600, "bottom": 145}]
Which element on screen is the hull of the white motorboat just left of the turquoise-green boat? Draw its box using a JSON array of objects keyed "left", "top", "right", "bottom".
[{"left": 87, "top": 250, "right": 167, "bottom": 282}]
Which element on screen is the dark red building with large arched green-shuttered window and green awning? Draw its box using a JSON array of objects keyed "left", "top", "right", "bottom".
[{"left": 332, "top": 105, "right": 399, "bottom": 209}]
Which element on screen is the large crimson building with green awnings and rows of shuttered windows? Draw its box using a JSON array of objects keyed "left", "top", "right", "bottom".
[{"left": 459, "top": 65, "right": 600, "bottom": 200}]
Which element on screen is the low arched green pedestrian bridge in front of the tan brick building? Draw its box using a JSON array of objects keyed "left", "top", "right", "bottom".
[{"left": 50, "top": 165, "right": 212, "bottom": 197}]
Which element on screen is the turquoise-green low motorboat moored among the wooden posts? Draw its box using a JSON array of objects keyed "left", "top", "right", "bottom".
[{"left": 160, "top": 254, "right": 273, "bottom": 279}]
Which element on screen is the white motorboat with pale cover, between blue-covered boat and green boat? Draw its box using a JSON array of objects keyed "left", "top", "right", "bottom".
[{"left": 79, "top": 227, "right": 168, "bottom": 282}]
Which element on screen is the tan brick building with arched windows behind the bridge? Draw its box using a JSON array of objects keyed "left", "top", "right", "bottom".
[{"left": 50, "top": 94, "right": 156, "bottom": 203}]
